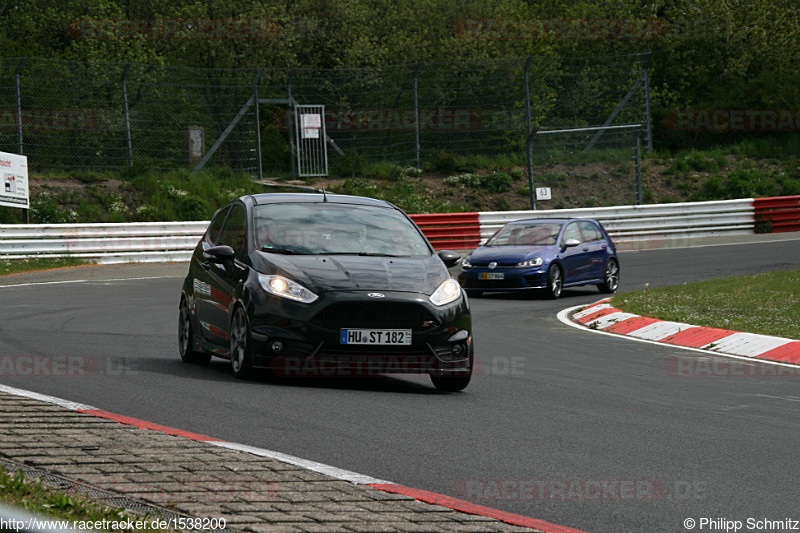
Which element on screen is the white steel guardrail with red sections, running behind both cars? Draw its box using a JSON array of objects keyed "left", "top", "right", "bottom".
[{"left": 0, "top": 196, "right": 800, "bottom": 263}]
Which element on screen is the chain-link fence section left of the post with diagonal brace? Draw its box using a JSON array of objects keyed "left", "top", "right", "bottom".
[{"left": 0, "top": 58, "right": 258, "bottom": 172}]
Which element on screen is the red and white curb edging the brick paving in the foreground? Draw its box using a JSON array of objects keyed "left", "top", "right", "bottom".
[{"left": 0, "top": 384, "right": 584, "bottom": 533}]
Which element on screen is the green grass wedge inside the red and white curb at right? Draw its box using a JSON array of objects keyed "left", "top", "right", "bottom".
[{"left": 611, "top": 270, "right": 800, "bottom": 339}]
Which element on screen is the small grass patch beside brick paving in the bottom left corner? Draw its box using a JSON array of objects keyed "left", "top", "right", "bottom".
[{"left": 0, "top": 466, "right": 169, "bottom": 531}]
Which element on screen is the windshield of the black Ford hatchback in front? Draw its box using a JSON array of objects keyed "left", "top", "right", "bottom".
[{"left": 255, "top": 202, "right": 431, "bottom": 257}]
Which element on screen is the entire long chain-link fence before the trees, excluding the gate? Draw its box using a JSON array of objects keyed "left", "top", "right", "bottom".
[{"left": 0, "top": 54, "right": 652, "bottom": 205}]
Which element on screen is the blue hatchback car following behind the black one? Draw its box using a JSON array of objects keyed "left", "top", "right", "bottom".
[{"left": 458, "top": 218, "right": 619, "bottom": 299}]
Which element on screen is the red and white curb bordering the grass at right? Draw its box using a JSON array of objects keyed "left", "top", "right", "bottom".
[{"left": 559, "top": 299, "right": 800, "bottom": 365}]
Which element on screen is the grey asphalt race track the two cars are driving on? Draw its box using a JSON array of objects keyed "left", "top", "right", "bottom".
[{"left": 0, "top": 240, "right": 800, "bottom": 532}]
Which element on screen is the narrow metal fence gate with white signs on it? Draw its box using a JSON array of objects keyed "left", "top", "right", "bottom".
[{"left": 294, "top": 105, "right": 328, "bottom": 178}]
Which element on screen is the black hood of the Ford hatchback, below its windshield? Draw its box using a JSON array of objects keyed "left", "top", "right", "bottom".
[{"left": 253, "top": 252, "right": 449, "bottom": 295}]
